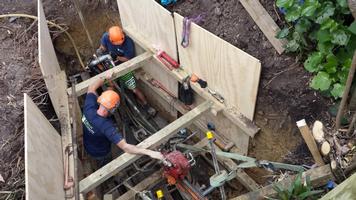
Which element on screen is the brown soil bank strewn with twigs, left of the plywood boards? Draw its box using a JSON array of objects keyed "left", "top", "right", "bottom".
[{"left": 0, "top": 0, "right": 40, "bottom": 199}]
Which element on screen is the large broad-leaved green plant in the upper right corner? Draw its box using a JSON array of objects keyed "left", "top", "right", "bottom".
[{"left": 276, "top": 0, "right": 356, "bottom": 99}]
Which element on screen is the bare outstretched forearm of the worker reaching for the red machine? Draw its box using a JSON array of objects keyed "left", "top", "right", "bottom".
[{"left": 116, "top": 139, "right": 163, "bottom": 160}]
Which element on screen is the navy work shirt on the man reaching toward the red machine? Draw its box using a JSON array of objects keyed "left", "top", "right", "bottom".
[{"left": 82, "top": 93, "right": 122, "bottom": 157}]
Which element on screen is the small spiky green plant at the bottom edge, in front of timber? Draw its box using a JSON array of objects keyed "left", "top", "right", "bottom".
[{"left": 269, "top": 172, "right": 324, "bottom": 200}]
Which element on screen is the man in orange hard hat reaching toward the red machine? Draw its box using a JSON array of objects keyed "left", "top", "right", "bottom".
[{"left": 82, "top": 72, "right": 163, "bottom": 167}]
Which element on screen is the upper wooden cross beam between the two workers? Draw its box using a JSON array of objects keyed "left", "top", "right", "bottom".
[{"left": 67, "top": 52, "right": 152, "bottom": 96}]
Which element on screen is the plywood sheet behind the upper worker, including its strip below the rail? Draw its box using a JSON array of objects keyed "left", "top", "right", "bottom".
[{"left": 117, "top": 0, "right": 178, "bottom": 95}]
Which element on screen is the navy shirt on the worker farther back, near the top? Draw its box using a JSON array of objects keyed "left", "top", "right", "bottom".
[{"left": 101, "top": 33, "right": 135, "bottom": 60}]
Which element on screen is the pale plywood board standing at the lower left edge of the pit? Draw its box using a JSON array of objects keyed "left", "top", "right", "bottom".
[{"left": 24, "top": 94, "right": 64, "bottom": 200}]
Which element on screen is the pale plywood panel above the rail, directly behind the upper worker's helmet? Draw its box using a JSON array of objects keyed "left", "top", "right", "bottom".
[{"left": 117, "top": 0, "right": 177, "bottom": 59}]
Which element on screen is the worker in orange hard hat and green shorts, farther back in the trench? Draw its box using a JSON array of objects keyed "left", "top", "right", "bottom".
[{"left": 96, "top": 26, "right": 156, "bottom": 116}]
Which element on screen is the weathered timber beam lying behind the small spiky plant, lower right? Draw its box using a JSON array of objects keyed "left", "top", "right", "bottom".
[{"left": 231, "top": 165, "right": 334, "bottom": 200}]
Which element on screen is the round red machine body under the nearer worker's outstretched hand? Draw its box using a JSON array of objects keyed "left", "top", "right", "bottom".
[{"left": 163, "top": 151, "right": 191, "bottom": 180}]
